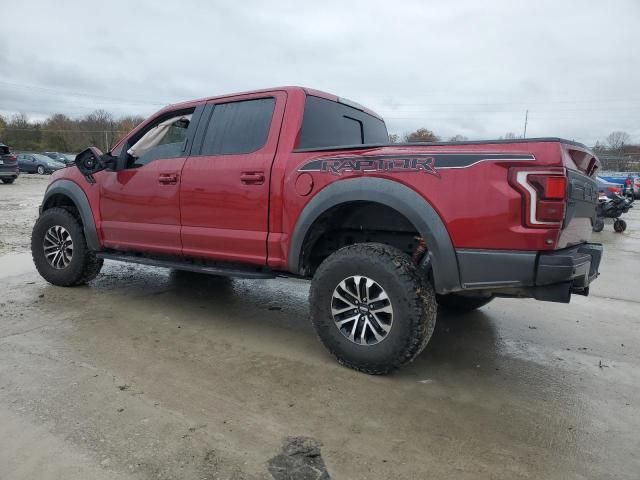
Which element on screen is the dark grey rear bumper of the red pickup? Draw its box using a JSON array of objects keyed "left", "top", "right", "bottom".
[{"left": 456, "top": 243, "right": 602, "bottom": 302}]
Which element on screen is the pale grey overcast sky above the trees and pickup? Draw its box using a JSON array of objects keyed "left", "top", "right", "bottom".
[{"left": 0, "top": 0, "right": 640, "bottom": 145}]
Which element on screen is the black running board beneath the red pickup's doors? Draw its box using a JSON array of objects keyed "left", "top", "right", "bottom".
[{"left": 96, "top": 252, "right": 276, "bottom": 278}]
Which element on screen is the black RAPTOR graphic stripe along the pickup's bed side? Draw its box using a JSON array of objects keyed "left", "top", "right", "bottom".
[{"left": 298, "top": 153, "right": 535, "bottom": 176}]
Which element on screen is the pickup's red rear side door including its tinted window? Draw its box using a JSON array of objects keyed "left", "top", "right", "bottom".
[{"left": 180, "top": 91, "right": 286, "bottom": 265}]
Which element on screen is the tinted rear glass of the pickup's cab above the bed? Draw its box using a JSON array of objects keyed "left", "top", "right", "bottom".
[{"left": 298, "top": 95, "right": 389, "bottom": 148}]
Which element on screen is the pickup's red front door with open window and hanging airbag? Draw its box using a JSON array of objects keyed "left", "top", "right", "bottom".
[{"left": 97, "top": 107, "right": 203, "bottom": 255}]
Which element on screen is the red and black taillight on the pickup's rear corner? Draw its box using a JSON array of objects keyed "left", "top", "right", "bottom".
[{"left": 509, "top": 167, "right": 567, "bottom": 228}]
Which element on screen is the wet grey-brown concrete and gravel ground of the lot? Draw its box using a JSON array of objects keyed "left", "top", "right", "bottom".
[{"left": 0, "top": 177, "right": 640, "bottom": 479}]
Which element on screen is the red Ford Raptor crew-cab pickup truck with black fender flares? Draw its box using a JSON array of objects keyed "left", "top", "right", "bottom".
[{"left": 32, "top": 87, "right": 602, "bottom": 374}]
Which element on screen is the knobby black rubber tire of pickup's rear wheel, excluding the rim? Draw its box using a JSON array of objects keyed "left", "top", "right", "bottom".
[{"left": 309, "top": 243, "right": 437, "bottom": 375}]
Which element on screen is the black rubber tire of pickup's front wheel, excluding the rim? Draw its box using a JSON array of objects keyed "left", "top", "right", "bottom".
[{"left": 31, "top": 207, "right": 103, "bottom": 287}]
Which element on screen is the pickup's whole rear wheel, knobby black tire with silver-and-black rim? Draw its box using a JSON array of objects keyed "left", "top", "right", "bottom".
[{"left": 310, "top": 243, "right": 437, "bottom": 375}]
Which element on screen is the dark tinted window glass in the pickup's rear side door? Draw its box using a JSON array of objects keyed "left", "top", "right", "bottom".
[{"left": 200, "top": 98, "right": 276, "bottom": 155}]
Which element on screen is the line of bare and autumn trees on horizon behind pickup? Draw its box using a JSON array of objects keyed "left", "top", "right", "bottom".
[{"left": 0, "top": 110, "right": 640, "bottom": 155}]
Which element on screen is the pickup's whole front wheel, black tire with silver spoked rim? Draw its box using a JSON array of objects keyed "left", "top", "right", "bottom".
[{"left": 31, "top": 208, "right": 102, "bottom": 287}]
